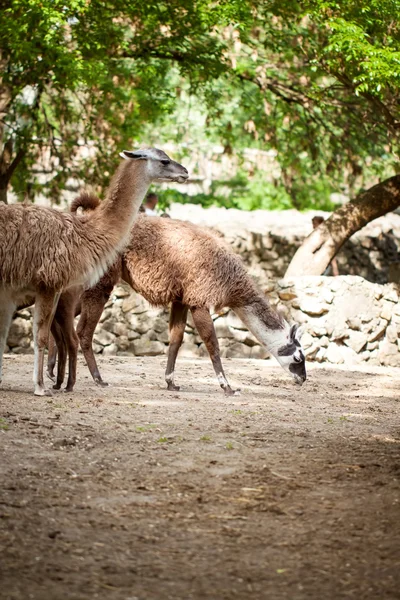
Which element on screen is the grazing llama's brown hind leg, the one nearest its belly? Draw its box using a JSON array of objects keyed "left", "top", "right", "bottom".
[{"left": 76, "top": 288, "right": 112, "bottom": 387}]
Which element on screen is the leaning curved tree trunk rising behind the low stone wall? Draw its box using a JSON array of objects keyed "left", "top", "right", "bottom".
[{"left": 285, "top": 175, "right": 400, "bottom": 277}]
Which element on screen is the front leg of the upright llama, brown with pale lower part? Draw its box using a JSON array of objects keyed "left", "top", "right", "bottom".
[{"left": 33, "top": 291, "right": 60, "bottom": 396}]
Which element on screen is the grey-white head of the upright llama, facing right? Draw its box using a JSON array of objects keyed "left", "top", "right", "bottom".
[{"left": 119, "top": 148, "right": 189, "bottom": 183}]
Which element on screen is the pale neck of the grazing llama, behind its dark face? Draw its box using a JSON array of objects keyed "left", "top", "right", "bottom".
[{"left": 234, "top": 296, "right": 289, "bottom": 357}]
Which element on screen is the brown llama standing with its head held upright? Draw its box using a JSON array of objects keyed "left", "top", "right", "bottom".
[{"left": 0, "top": 148, "right": 188, "bottom": 396}]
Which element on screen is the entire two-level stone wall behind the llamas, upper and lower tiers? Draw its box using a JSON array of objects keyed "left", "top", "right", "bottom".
[{"left": 8, "top": 205, "right": 400, "bottom": 364}]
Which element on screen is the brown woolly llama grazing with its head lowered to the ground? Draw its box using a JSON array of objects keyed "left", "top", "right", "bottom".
[{"left": 48, "top": 198, "right": 306, "bottom": 395}]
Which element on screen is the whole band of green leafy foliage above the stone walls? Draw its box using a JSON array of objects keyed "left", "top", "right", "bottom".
[{"left": 0, "top": 0, "right": 400, "bottom": 210}]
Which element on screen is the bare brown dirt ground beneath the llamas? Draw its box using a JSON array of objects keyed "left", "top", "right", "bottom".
[{"left": 0, "top": 355, "right": 400, "bottom": 600}]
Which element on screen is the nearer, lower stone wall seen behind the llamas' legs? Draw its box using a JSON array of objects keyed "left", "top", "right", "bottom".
[{"left": 8, "top": 276, "right": 400, "bottom": 366}]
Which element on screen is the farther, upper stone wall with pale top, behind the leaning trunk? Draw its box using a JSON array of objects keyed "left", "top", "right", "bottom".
[{"left": 166, "top": 204, "right": 400, "bottom": 286}]
